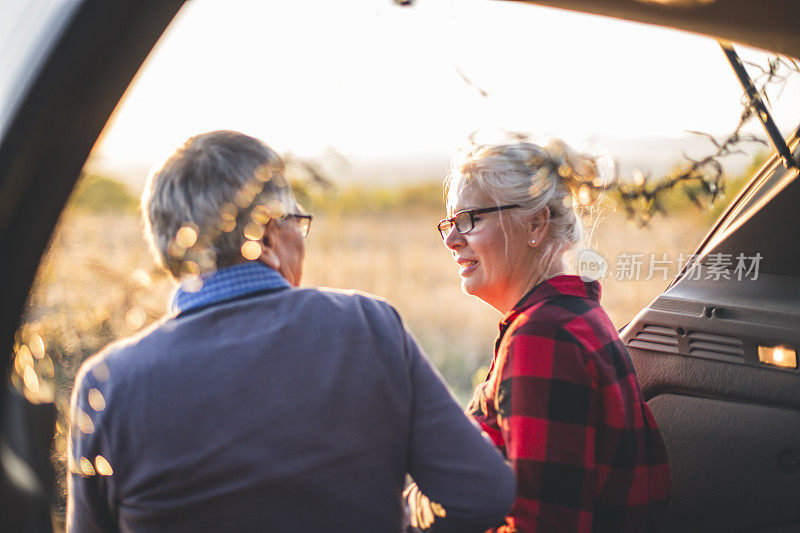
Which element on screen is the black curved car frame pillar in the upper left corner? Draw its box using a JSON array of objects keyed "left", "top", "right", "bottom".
[{"left": 0, "top": 0, "right": 183, "bottom": 400}]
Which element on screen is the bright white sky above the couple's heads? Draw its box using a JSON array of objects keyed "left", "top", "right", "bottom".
[{"left": 95, "top": 0, "right": 800, "bottom": 169}]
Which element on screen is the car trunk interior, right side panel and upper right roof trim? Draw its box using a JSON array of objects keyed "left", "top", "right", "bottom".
[{"left": 530, "top": 0, "right": 800, "bottom": 532}]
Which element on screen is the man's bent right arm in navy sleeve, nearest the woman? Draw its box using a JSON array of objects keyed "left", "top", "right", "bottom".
[{"left": 406, "top": 328, "right": 516, "bottom": 532}]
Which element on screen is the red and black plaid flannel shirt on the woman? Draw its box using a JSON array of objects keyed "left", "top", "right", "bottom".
[{"left": 467, "top": 275, "right": 670, "bottom": 533}]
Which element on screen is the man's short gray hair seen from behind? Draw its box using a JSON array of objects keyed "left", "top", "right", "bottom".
[{"left": 142, "top": 131, "right": 298, "bottom": 279}]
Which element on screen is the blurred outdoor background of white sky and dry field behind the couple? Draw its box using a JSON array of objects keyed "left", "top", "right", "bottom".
[{"left": 7, "top": 0, "right": 800, "bottom": 517}]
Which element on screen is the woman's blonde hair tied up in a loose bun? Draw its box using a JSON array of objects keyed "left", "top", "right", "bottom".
[{"left": 445, "top": 139, "right": 598, "bottom": 258}]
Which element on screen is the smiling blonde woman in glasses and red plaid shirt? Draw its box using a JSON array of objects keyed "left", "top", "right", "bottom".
[{"left": 439, "top": 141, "right": 669, "bottom": 532}]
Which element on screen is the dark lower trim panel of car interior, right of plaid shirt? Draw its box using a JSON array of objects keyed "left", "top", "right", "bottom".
[{"left": 650, "top": 394, "right": 800, "bottom": 532}]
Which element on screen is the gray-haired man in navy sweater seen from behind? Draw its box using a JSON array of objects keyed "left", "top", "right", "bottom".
[{"left": 67, "top": 131, "right": 515, "bottom": 532}]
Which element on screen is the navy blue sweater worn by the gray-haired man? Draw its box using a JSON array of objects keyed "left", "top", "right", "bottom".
[{"left": 67, "top": 288, "right": 515, "bottom": 532}]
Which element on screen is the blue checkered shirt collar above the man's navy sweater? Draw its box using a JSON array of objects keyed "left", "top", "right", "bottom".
[{"left": 170, "top": 261, "right": 290, "bottom": 314}]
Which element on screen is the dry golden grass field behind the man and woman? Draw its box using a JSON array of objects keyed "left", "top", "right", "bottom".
[{"left": 12, "top": 183, "right": 707, "bottom": 524}]
